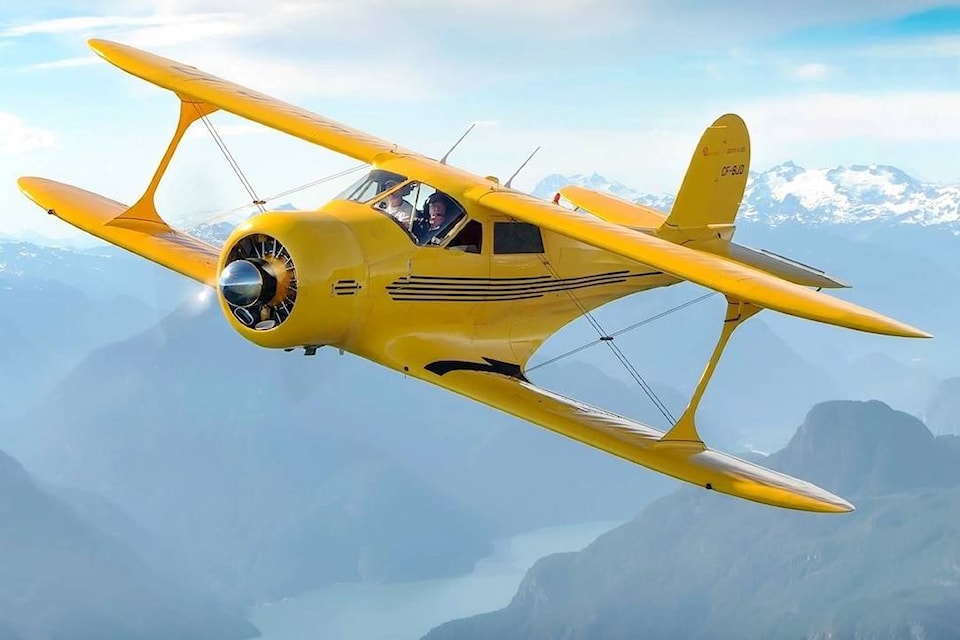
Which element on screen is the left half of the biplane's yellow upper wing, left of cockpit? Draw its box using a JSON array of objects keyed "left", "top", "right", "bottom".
[{"left": 89, "top": 40, "right": 415, "bottom": 163}]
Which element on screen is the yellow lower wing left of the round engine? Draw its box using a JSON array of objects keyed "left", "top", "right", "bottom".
[{"left": 17, "top": 178, "right": 220, "bottom": 286}]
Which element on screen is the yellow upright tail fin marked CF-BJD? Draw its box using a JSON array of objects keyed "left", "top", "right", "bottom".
[{"left": 661, "top": 113, "right": 750, "bottom": 239}]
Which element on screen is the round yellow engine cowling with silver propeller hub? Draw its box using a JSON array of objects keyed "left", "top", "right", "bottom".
[{"left": 217, "top": 211, "right": 366, "bottom": 348}]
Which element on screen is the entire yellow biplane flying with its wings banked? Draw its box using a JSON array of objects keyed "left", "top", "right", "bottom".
[{"left": 19, "top": 40, "right": 929, "bottom": 512}]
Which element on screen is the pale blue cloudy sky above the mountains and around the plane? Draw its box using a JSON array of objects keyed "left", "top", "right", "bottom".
[{"left": 0, "top": 0, "right": 960, "bottom": 241}]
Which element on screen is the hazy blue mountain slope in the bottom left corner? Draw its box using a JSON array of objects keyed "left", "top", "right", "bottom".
[{"left": 0, "top": 444, "right": 258, "bottom": 640}]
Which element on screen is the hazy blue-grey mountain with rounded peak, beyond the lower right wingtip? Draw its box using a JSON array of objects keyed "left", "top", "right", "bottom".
[{"left": 426, "top": 401, "right": 960, "bottom": 640}]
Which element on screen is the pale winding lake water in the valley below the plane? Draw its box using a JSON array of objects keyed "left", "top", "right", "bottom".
[{"left": 248, "top": 522, "right": 621, "bottom": 640}]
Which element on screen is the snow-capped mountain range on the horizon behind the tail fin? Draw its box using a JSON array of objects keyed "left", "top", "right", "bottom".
[{"left": 533, "top": 162, "right": 960, "bottom": 231}]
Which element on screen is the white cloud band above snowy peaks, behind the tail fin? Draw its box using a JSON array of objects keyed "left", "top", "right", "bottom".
[{"left": 444, "top": 92, "right": 960, "bottom": 193}]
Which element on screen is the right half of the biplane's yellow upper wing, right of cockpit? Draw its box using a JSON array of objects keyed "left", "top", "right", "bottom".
[{"left": 473, "top": 190, "right": 930, "bottom": 338}]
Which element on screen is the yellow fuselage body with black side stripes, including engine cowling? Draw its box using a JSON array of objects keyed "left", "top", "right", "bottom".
[{"left": 219, "top": 201, "right": 678, "bottom": 375}]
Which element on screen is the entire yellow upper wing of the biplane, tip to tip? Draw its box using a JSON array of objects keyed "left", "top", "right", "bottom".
[{"left": 90, "top": 40, "right": 929, "bottom": 337}]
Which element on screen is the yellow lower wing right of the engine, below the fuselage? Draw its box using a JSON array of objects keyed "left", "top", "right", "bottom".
[{"left": 421, "top": 363, "right": 853, "bottom": 513}]
